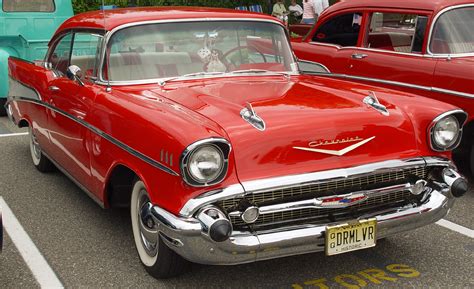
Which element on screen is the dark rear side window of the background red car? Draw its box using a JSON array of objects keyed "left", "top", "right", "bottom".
[{"left": 313, "top": 13, "right": 362, "bottom": 46}]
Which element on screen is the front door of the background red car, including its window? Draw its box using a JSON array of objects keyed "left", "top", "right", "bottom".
[{"left": 346, "top": 11, "right": 437, "bottom": 88}]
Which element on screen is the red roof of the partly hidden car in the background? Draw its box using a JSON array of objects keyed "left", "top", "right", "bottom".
[{"left": 325, "top": 0, "right": 473, "bottom": 14}]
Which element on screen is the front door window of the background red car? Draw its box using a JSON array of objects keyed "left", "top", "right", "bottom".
[{"left": 366, "top": 12, "right": 427, "bottom": 53}]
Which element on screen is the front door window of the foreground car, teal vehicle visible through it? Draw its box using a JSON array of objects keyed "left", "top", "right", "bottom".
[{"left": 71, "top": 32, "right": 102, "bottom": 78}]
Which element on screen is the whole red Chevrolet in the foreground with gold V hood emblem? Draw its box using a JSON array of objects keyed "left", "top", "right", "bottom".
[{"left": 3, "top": 7, "right": 467, "bottom": 278}]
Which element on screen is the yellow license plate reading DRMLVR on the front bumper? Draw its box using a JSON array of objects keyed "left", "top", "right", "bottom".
[{"left": 326, "top": 219, "right": 377, "bottom": 256}]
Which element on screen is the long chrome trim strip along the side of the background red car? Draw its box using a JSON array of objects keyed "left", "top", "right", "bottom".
[{"left": 306, "top": 72, "right": 474, "bottom": 99}]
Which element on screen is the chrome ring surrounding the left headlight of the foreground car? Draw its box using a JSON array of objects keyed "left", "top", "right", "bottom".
[{"left": 181, "top": 138, "right": 231, "bottom": 187}]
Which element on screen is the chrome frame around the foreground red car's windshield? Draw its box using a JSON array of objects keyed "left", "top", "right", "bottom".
[{"left": 96, "top": 17, "right": 299, "bottom": 86}]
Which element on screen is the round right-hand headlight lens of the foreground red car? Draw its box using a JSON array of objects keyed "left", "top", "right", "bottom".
[{"left": 432, "top": 115, "right": 460, "bottom": 150}]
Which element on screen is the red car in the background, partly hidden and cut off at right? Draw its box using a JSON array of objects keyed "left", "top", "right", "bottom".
[{"left": 292, "top": 0, "right": 474, "bottom": 174}]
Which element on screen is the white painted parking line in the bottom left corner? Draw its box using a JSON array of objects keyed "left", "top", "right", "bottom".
[{"left": 0, "top": 197, "right": 64, "bottom": 288}]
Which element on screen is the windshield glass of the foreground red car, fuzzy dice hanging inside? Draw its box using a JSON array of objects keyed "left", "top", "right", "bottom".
[{"left": 104, "top": 21, "right": 297, "bottom": 81}]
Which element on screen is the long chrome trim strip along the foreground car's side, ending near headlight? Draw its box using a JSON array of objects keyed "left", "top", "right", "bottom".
[{"left": 9, "top": 96, "right": 179, "bottom": 176}]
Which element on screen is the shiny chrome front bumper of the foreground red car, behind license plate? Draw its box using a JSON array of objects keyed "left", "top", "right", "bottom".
[{"left": 152, "top": 188, "right": 454, "bottom": 265}]
